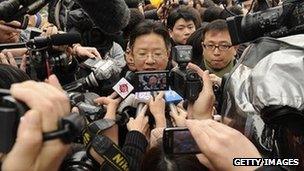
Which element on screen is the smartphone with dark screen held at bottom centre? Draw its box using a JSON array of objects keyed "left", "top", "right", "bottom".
[{"left": 163, "top": 127, "right": 201, "bottom": 154}]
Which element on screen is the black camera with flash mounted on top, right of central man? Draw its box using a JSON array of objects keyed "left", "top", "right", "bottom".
[{"left": 170, "top": 45, "right": 202, "bottom": 101}]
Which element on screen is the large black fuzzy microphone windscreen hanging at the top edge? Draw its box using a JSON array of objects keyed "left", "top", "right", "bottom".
[{"left": 76, "top": 0, "right": 130, "bottom": 34}]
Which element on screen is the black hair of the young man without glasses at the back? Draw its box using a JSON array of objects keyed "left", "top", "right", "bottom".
[{"left": 167, "top": 6, "right": 201, "bottom": 30}]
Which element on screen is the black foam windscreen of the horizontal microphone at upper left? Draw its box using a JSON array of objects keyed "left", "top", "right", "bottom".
[{"left": 50, "top": 33, "right": 81, "bottom": 46}]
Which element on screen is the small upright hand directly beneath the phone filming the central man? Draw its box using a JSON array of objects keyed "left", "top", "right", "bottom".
[{"left": 149, "top": 92, "right": 166, "bottom": 128}]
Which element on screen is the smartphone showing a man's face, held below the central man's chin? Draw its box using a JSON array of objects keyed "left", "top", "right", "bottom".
[{"left": 135, "top": 70, "right": 169, "bottom": 92}]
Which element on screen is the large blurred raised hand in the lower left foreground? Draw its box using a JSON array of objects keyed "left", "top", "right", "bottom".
[{"left": 2, "top": 75, "right": 70, "bottom": 170}]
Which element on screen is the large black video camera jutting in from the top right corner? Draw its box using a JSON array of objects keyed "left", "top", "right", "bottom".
[{"left": 227, "top": 0, "right": 304, "bottom": 45}]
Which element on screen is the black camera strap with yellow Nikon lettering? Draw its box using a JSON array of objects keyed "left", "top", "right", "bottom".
[{"left": 87, "top": 135, "right": 129, "bottom": 171}]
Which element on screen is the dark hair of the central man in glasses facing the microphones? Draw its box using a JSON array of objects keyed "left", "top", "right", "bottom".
[{"left": 129, "top": 20, "right": 171, "bottom": 50}]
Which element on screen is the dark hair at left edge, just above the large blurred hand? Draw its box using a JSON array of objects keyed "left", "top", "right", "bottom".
[{"left": 0, "top": 64, "right": 30, "bottom": 89}]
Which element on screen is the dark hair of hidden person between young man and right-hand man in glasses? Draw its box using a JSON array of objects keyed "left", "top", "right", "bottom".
[{"left": 186, "top": 22, "right": 208, "bottom": 67}]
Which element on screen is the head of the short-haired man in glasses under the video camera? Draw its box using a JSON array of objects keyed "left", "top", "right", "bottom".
[{"left": 202, "top": 20, "right": 237, "bottom": 78}]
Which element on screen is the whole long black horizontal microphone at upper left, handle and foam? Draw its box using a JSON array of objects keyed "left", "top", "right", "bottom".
[{"left": 26, "top": 33, "right": 81, "bottom": 47}]
